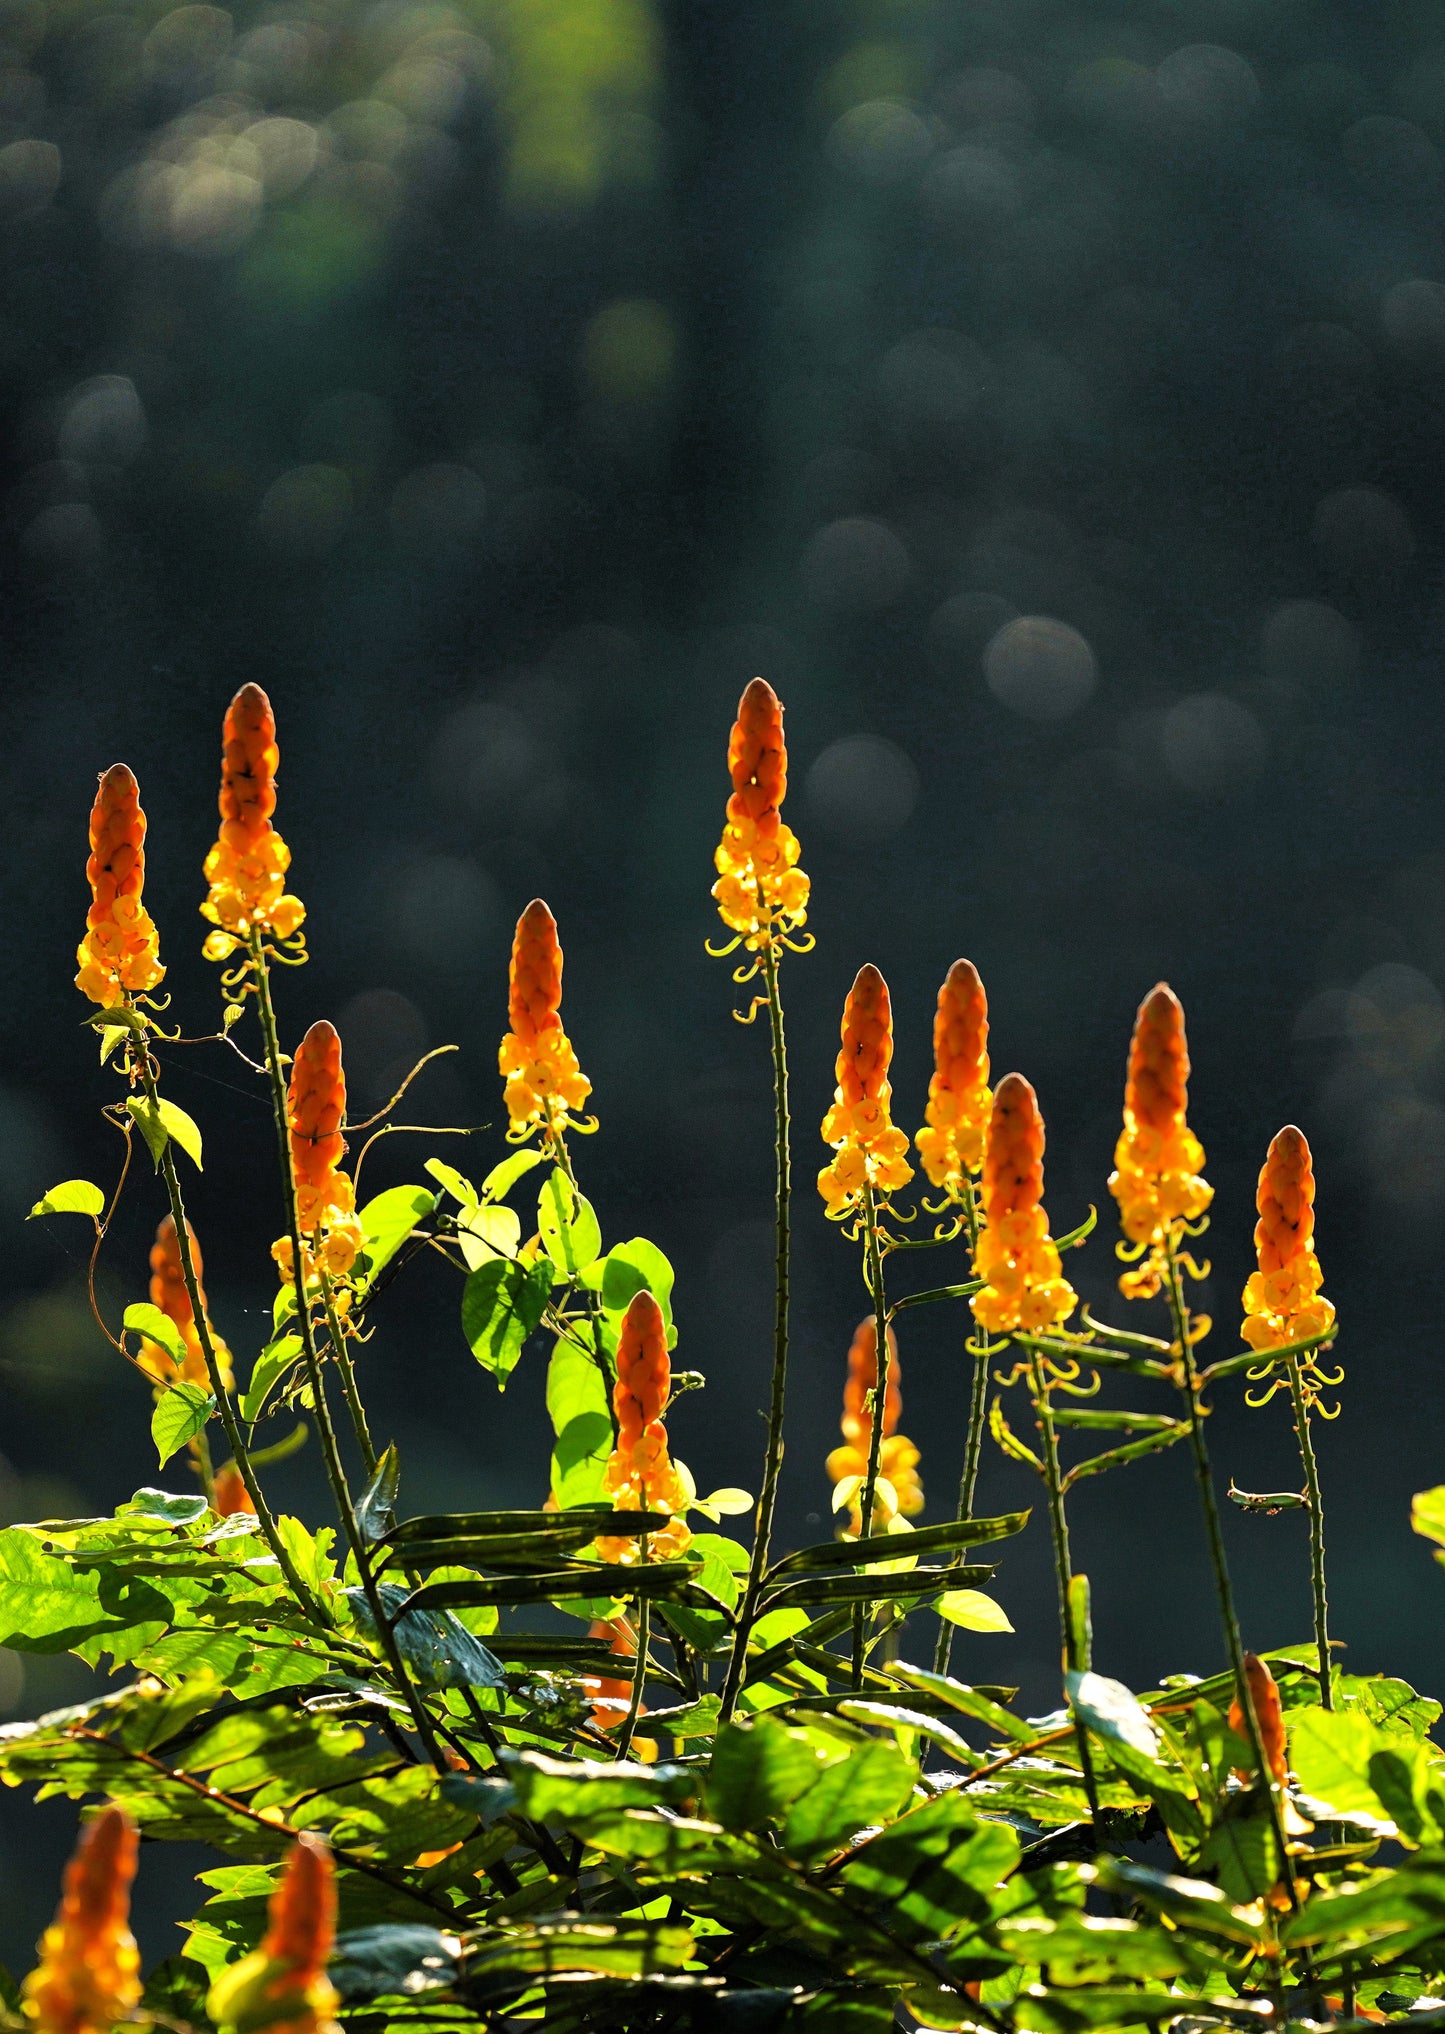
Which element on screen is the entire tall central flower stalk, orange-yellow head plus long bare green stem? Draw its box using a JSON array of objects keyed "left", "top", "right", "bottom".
[{"left": 708, "top": 677, "right": 812, "bottom": 1719}]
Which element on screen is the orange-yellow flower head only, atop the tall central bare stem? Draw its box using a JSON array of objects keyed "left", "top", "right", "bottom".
[{"left": 712, "top": 677, "right": 810, "bottom": 952}]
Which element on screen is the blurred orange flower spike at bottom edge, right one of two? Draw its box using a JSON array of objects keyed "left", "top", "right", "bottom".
[{"left": 208, "top": 1835, "right": 338, "bottom": 2034}]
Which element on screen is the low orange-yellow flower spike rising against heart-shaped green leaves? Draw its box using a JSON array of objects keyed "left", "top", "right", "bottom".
[{"left": 596, "top": 1292, "right": 696, "bottom": 1562}]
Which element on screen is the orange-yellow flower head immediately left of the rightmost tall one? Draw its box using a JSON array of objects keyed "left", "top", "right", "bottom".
[{"left": 1109, "top": 982, "right": 1215, "bottom": 1300}]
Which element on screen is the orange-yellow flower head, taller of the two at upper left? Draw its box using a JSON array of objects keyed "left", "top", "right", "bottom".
[{"left": 201, "top": 685, "right": 305, "bottom": 960}]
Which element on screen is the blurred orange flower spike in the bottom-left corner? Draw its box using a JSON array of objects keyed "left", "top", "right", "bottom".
[{"left": 22, "top": 1808, "right": 140, "bottom": 2034}]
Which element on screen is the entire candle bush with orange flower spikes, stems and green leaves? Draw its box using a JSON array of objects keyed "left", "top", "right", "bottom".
[{"left": 0, "top": 679, "right": 1445, "bottom": 2034}]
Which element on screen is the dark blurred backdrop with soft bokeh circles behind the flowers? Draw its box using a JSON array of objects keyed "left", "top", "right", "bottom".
[{"left": 0, "top": 0, "right": 1445, "bottom": 1969}]
